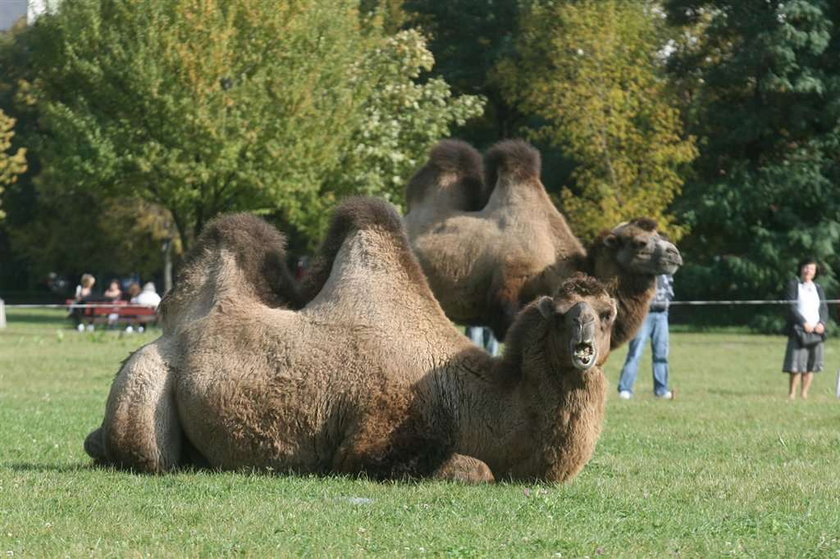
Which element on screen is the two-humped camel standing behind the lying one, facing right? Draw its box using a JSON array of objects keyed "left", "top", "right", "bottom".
[{"left": 404, "top": 140, "right": 682, "bottom": 348}]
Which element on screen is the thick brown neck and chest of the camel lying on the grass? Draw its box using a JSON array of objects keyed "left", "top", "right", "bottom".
[{"left": 440, "top": 346, "right": 607, "bottom": 481}]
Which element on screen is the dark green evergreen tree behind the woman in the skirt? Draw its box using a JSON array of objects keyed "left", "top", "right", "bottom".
[{"left": 667, "top": 0, "right": 840, "bottom": 314}]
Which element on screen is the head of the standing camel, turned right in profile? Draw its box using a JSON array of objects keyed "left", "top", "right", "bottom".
[{"left": 599, "top": 218, "right": 682, "bottom": 277}]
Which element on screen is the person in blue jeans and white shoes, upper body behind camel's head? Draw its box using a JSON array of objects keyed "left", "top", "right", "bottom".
[{"left": 618, "top": 274, "right": 674, "bottom": 400}]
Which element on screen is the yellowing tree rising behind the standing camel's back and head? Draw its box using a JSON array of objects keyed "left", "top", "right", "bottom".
[{"left": 496, "top": 0, "right": 696, "bottom": 238}]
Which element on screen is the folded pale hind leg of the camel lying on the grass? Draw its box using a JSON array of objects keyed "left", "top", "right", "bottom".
[{"left": 85, "top": 343, "right": 183, "bottom": 473}]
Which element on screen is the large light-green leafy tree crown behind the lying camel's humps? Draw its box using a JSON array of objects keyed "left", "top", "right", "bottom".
[{"left": 11, "top": 0, "right": 478, "bottom": 255}]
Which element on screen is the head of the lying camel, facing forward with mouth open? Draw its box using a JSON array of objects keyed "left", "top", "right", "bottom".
[{"left": 536, "top": 274, "right": 617, "bottom": 372}]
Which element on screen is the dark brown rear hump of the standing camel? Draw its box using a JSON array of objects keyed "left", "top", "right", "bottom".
[{"left": 406, "top": 140, "right": 486, "bottom": 211}]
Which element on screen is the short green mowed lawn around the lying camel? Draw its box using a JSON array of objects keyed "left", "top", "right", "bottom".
[{"left": 0, "top": 311, "right": 840, "bottom": 557}]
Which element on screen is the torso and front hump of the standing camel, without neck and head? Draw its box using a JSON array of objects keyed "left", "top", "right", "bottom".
[{"left": 405, "top": 140, "right": 585, "bottom": 339}]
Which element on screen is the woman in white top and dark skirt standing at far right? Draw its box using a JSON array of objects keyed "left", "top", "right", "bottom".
[{"left": 782, "top": 258, "right": 828, "bottom": 400}]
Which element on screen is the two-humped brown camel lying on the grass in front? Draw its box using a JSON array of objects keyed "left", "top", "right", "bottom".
[{"left": 85, "top": 198, "right": 616, "bottom": 482}]
